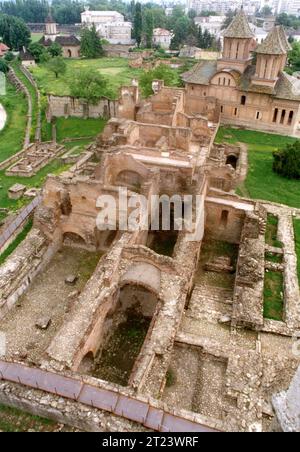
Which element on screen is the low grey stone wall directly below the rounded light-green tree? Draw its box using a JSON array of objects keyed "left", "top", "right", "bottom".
[{"left": 47, "top": 95, "right": 118, "bottom": 121}]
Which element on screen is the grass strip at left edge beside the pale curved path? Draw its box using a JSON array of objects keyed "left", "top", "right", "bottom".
[{"left": 0, "top": 83, "right": 27, "bottom": 162}]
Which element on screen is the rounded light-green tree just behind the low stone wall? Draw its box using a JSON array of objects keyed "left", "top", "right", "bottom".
[{"left": 71, "top": 69, "right": 111, "bottom": 105}]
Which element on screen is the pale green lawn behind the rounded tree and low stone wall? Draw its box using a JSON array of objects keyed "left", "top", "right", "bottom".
[{"left": 31, "top": 58, "right": 141, "bottom": 98}]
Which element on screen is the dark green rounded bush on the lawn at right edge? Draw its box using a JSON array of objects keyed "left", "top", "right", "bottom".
[{"left": 273, "top": 140, "right": 300, "bottom": 179}]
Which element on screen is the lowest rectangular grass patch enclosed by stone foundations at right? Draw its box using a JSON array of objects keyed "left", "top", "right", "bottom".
[{"left": 264, "top": 272, "right": 283, "bottom": 321}]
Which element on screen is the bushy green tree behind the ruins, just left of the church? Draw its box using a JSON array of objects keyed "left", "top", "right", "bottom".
[{"left": 140, "top": 64, "right": 180, "bottom": 97}]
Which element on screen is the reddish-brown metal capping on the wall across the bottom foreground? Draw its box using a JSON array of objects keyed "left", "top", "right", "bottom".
[{"left": 0, "top": 361, "right": 217, "bottom": 432}]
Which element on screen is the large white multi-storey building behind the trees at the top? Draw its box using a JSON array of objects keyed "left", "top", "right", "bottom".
[{"left": 81, "top": 10, "right": 133, "bottom": 45}]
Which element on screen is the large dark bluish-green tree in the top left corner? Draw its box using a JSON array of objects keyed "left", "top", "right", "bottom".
[{"left": 0, "top": 14, "right": 31, "bottom": 50}]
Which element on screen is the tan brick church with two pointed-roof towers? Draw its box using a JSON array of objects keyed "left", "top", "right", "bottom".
[{"left": 183, "top": 10, "right": 300, "bottom": 136}]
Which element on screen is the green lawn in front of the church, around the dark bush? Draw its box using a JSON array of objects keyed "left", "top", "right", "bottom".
[{"left": 216, "top": 127, "right": 300, "bottom": 208}]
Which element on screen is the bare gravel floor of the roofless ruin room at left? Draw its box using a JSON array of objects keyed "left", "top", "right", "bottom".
[{"left": 0, "top": 248, "right": 99, "bottom": 363}]
